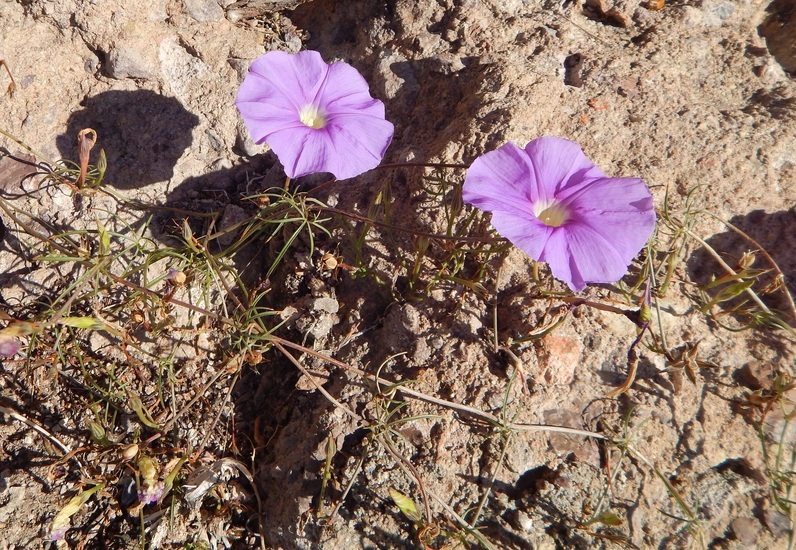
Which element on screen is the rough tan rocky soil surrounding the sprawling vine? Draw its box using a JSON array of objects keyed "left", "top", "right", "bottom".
[{"left": 0, "top": 0, "right": 796, "bottom": 550}]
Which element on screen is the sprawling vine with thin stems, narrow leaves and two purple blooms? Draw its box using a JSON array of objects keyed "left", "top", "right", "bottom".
[{"left": 0, "top": 44, "right": 796, "bottom": 548}]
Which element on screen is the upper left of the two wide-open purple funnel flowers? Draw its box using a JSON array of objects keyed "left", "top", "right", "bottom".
[{"left": 235, "top": 51, "right": 393, "bottom": 179}]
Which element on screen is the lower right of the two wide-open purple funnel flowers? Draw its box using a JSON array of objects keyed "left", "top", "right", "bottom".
[{"left": 462, "top": 137, "right": 655, "bottom": 292}]
